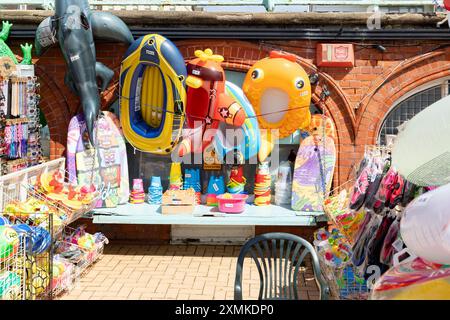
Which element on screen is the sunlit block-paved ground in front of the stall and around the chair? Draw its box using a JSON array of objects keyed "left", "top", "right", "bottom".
[{"left": 59, "top": 244, "right": 319, "bottom": 300}]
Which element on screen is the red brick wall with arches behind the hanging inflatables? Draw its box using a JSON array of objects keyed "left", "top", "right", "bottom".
[{"left": 9, "top": 39, "right": 450, "bottom": 185}]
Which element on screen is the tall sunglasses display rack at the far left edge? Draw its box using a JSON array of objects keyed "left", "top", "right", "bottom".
[{"left": 0, "top": 76, "right": 43, "bottom": 175}]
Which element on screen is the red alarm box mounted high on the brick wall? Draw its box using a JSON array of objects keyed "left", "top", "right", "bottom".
[{"left": 316, "top": 43, "right": 355, "bottom": 68}]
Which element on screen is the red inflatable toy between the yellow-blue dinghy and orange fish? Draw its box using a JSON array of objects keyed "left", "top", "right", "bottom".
[{"left": 178, "top": 49, "right": 246, "bottom": 157}]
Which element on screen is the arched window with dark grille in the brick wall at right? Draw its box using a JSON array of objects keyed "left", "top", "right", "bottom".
[{"left": 378, "top": 79, "right": 450, "bottom": 145}]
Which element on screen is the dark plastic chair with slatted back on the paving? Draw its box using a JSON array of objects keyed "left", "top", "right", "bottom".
[{"left": 234, "top": 232, "right": 330, "bottom": 300}]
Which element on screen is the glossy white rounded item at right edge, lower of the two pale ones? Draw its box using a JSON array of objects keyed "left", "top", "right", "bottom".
[{"left": 400, "top": 184, "right": 450, "bottom": 264}]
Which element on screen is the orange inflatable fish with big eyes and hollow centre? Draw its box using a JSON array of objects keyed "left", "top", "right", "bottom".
[{"left": 242, "top": 51, "right": 311, "bottom": 161}]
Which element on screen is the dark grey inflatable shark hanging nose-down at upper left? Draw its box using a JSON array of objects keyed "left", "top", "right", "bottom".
[{"left": 35, "top": 0, "right": 134, "bottom": 143}]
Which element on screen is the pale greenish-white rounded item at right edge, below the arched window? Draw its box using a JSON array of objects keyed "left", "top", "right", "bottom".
[{"left": 392, "top": 96, "right": 450, "bottom": 186}]
